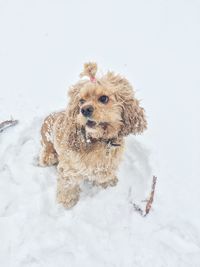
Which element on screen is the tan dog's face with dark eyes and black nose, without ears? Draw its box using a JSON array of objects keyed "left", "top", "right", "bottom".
[{"left": 77, "top": 83, "right": 123, "bottom": 139}]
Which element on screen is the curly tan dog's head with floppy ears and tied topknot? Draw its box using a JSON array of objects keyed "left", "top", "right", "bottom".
[{"left": 66, "top": 64, "right": 147, "bottom": 146}]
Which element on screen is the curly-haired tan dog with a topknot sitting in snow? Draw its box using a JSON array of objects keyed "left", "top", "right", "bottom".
[{"left": 40, "top": 63, "right": 147, "bottom": 208}]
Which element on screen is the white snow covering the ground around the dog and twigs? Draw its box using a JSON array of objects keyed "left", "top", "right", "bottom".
[{"left": 0, "top": 0, "right": 200, "bottom": 267}]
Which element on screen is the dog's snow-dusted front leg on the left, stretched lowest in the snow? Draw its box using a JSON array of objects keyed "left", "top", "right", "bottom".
[{"left": 57, "top": 166, "right": 80, "bottom": 209}]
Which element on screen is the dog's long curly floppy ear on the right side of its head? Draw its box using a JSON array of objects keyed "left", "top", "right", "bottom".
[{"left": 106, "top": 72, "right": 147, "bottom": 136}]
